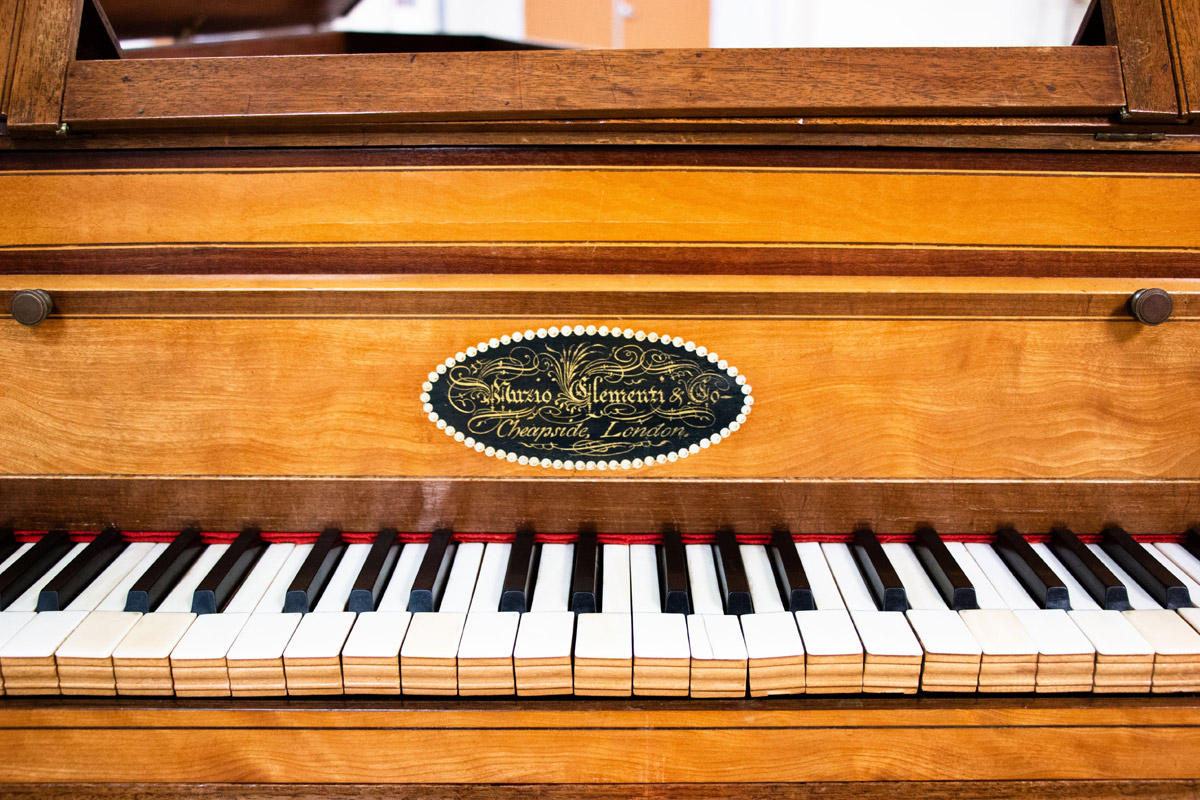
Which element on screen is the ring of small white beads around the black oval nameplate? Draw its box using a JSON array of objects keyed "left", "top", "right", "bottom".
[{"left": 421, "top": 325, "right": 754, "bottom": 471}]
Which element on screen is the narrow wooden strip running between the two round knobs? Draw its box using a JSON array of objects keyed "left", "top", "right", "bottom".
[{"left": 0, "top": 276, "right": 1200, "bottom": 323}]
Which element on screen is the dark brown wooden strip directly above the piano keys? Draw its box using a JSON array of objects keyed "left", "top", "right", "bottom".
[{"left": 0, "top": 476, "right": 1200, "bottom": 534}]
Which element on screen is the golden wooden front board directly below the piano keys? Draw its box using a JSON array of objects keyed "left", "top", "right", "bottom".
[{"left": 0, "top": 698, "right": 1200, "bottom": 783}]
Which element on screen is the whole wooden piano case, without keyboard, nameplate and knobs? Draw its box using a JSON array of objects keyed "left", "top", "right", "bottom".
[{"left": 0, "top": 0, "right": 1200, "bottom": 798}]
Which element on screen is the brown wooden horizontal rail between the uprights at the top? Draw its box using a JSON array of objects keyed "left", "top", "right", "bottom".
[{"left": 56, "top": 47, "right": 1124, "bottom": 130}]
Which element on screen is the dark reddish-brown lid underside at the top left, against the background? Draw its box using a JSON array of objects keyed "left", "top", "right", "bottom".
[{"left": 102, "top": 0, "right": 358, "bottom": 38}]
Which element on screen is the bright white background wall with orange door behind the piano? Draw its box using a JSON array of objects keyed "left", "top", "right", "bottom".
[{"left": 335, "top": 0, "right": 1088, "bottom": 48}]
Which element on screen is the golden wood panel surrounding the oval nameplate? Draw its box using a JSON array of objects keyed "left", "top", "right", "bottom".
[{"left": 0, "top": 309, "right": 1200, "bottom": 479}]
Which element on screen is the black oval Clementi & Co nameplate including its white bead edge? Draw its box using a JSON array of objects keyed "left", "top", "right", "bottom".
[{"left": 421, "top": 325, "right": 754, "bottom": 469}]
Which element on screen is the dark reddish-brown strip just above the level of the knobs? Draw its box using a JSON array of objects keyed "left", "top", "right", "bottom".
[{"left": 7, "top": 242, "right": 1200, "bottom": 278}]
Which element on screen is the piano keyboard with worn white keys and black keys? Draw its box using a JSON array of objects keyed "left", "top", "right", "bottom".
[{"left": 0, "top": 528, "right": 1200, "bottom": 697}]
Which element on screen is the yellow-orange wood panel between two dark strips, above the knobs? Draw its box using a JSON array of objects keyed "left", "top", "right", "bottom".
[{"left": 7, "top": 163, "right": 1200, "bottom": 253}]
